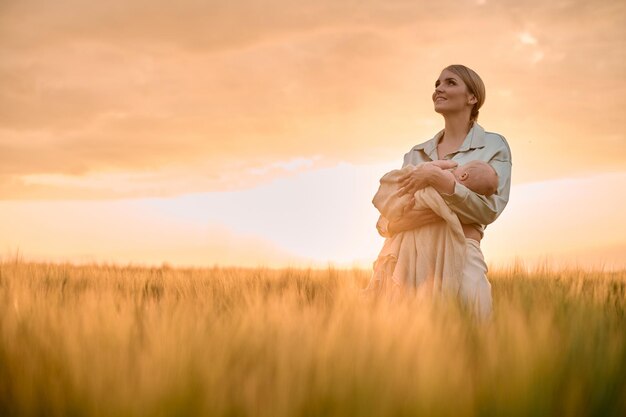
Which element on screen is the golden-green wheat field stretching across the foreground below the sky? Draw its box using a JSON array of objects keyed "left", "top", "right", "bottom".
[{"left": 0, "top": 260, "right": 626, "bottom": 417}]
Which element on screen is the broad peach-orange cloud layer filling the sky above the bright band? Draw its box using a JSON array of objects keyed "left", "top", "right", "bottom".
[{"left": 0, "top": 0, "right": 626, "bottom": 199}]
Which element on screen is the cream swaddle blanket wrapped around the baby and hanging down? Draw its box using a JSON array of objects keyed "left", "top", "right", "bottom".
[{"left": 367, "top": 165, "right": 466, "bottom": 296}]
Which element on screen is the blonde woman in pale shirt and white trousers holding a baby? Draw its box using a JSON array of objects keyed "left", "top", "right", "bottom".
[{"left": 377, "top": 65, "right": 511, "bottom": 319}]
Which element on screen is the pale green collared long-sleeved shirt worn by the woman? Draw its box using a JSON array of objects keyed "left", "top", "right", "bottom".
[{"left": 377, "top": 123, "right": 511, "bottom": 236}]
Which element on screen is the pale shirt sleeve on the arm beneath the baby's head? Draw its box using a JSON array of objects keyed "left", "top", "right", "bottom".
[{"left": 441, "top": 142, "right": 512, "bottom": 225}]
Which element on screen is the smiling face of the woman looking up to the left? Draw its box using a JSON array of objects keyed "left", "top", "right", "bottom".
[{"left": 433, "top": 70, "right": 476, "bottom": 114}]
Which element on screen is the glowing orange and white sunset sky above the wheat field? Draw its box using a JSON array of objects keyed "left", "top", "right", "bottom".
[{"left": 0, "top": 0, "right": 626, "bottom": 269}]
